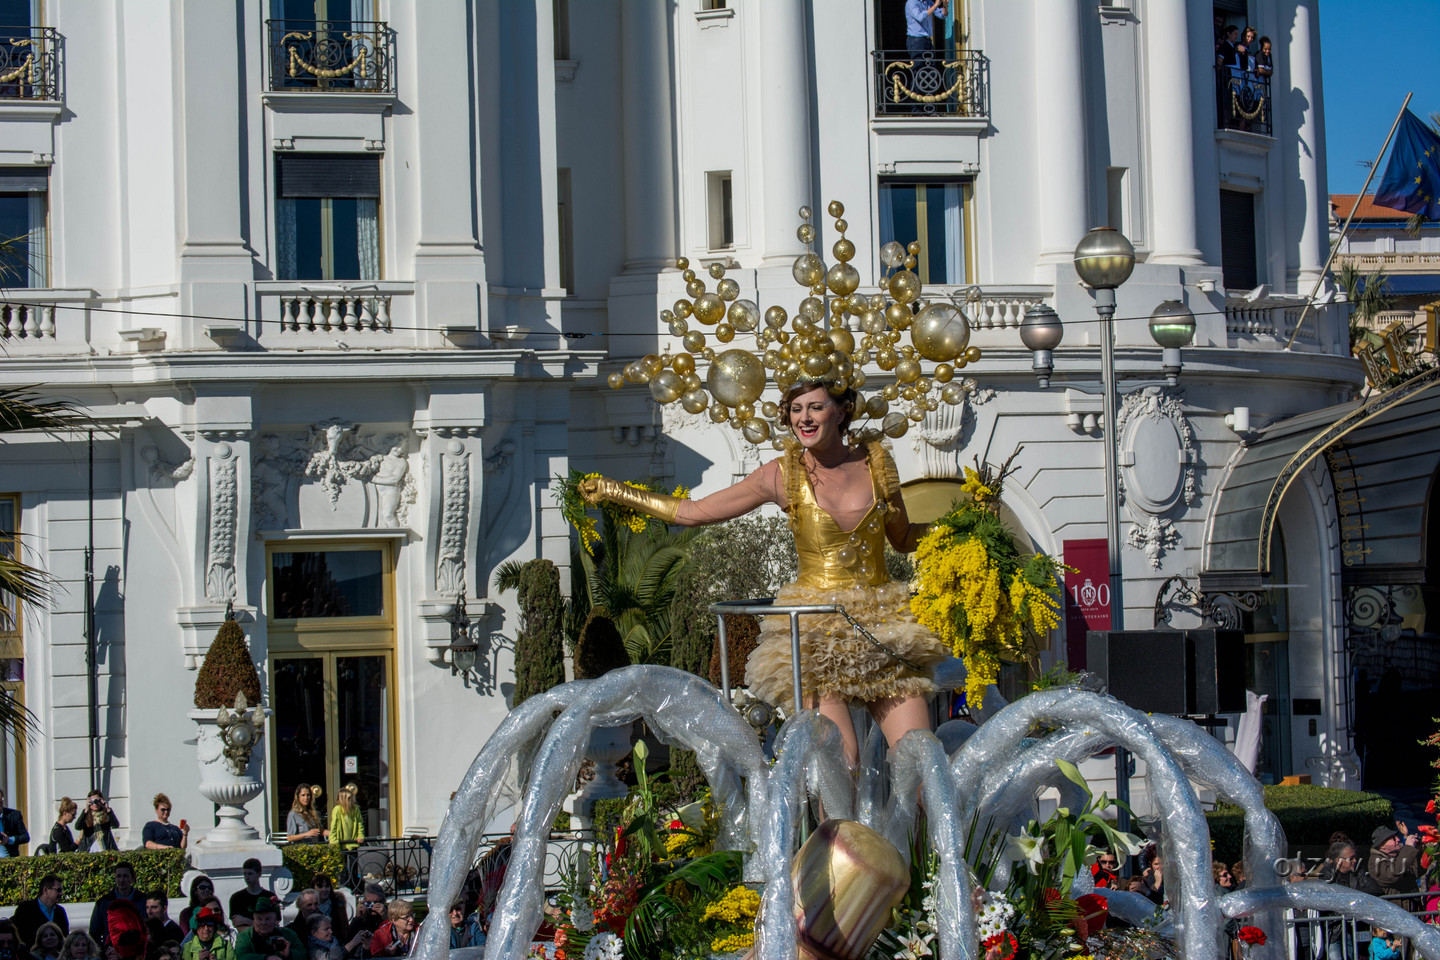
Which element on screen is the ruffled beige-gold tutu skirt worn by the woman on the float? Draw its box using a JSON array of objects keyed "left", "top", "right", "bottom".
[{"left": 746, "top": 583, "right": 950, "bottom": 708}]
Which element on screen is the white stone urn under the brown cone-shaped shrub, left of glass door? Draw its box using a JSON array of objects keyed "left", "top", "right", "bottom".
[{"left": 190, "top": 694, "right": 271, "bottom": 843}]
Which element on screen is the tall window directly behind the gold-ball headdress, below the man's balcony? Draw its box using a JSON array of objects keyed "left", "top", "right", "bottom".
[{"left": 876, "top": 180, "right": 972, "bottom": 286}]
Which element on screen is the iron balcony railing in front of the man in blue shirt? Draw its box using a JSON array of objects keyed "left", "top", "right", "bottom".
[{"left": 871, "top": 50, "right": 989, "bottom": 118}]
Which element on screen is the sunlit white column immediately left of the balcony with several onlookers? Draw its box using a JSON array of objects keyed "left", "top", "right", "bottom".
[{"left": 1145, "top": 3, "right": 1203, "bottom": 263}]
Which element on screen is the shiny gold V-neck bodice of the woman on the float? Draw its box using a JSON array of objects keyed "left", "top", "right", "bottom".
[{"left": 780, "top": 440, "right": 894, "bottom": 589}]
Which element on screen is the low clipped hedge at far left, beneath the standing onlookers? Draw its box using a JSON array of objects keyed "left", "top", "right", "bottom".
[{"left": 0, "top": 851, "right": 190, "bottom": 907}]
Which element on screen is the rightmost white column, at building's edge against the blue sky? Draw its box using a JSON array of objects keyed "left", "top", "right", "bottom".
[{"left": 1270, "top": 0, "right": 1331, "bottom": 295}]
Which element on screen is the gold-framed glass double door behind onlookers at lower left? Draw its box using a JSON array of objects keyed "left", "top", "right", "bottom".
[{"left": 271, "top": 651, "right": 399, "bottom": 836}]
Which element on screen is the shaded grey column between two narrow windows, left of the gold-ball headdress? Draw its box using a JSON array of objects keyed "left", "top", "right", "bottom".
[{"left": 621, "top": 0, "right": 678, "bottom": 273}]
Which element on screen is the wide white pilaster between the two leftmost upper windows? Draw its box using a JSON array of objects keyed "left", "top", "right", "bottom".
[{"left": 176, "top": 3, "right": 255, "bottom": 347}]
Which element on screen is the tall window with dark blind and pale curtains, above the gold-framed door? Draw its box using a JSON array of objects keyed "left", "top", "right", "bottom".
[{"left": 275, "top": 154, "right": 380, "bottom": 281}]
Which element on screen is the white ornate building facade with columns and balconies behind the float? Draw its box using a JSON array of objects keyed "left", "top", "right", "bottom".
[{"left": 0, "top": 0, "right": 1399, "bottom": 841}]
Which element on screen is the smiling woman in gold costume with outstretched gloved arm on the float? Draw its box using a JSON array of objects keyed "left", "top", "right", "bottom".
[{"left": 580, "top": 380, "right": 950, "bottom": 766}]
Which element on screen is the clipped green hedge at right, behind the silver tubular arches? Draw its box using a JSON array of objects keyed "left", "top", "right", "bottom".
[{"left": 1205, "top": 783, "right": 1395, "bottom": 864}]
